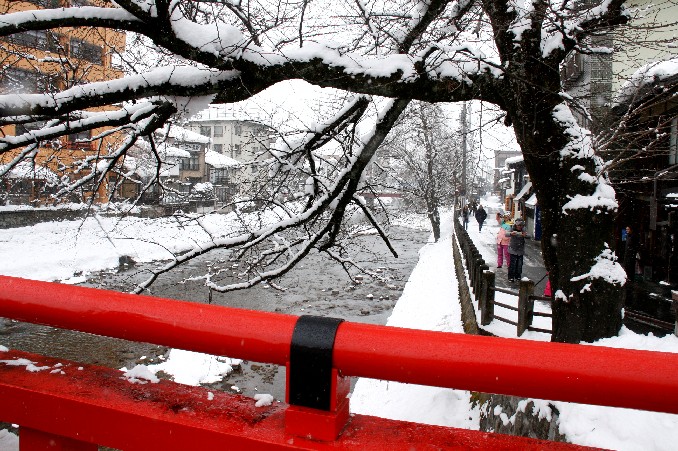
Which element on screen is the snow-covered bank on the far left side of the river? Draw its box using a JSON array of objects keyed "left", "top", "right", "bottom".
[{"left": 0, "top": 215, "right": 236, "bottom": 281}]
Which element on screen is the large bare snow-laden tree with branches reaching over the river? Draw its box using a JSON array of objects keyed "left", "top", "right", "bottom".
[{"left": 0, "top": 0, "right": 652, "bottom": 342}]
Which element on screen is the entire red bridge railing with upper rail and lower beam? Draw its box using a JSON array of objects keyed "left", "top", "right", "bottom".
[{"left": 0, "top": 277, "right": 678, "bottom": 450}]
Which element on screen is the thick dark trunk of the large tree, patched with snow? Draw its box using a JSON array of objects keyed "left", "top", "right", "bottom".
[{"left": 509, "top": 74, "right": 625, "bottom": 343}]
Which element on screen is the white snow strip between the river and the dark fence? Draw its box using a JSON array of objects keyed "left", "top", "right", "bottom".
[{"left": 351, "top": 215, "right": 479, "bottom": 430}]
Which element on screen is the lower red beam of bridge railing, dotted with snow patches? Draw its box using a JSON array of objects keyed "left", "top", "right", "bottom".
[{"left": 0, "top": 351, "right": 590, "bottom": 451}]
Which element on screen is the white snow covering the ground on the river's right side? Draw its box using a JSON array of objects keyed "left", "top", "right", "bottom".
[{"left": 351, "top": 203, "right": 678, "bottom": 451}]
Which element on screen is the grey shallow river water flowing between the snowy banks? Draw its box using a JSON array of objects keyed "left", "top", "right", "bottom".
[{"left": 0, "top": 227, "right": 430, "bottom": 400}]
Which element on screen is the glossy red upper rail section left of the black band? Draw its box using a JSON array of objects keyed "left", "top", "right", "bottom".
[{"left": 0, "top": 276, "right": 297, "bottom": 365}]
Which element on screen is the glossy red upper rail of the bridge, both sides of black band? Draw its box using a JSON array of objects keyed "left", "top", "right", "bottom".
[{"left": 0, "top": 277, "right": 678, "bottom": 413}]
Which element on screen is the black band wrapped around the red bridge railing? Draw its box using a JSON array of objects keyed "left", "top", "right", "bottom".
[{"left": 289, "top": 315, "right": 344, "bottom": 410}]
